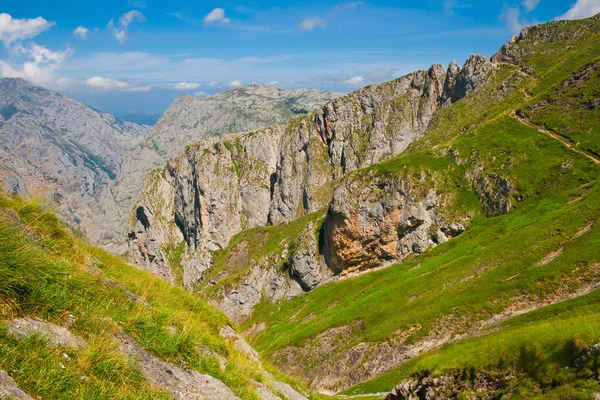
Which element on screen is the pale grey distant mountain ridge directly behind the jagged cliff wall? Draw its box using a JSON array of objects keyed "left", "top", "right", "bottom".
[{"left": 113, "top": 85, "right": 339, "bottom": 250}]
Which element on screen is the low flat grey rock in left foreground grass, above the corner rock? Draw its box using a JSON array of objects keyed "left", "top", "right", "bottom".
[{"left": 5, "top": 318, "right": 87, "bottom": 350}]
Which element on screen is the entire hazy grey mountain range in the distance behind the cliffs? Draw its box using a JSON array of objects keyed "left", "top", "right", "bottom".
[{"left": 0, "top": 78, "right": 338, "bottom": 254}]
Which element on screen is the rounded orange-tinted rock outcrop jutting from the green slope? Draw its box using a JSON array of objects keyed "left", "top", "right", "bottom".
[{"left": 323, "top": 169, "right": 469, "bottom": 274}]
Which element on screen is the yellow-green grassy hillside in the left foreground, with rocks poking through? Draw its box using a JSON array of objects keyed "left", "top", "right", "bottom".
[{"left": 0, "top": 194, "right": 302, "bottom": 399}]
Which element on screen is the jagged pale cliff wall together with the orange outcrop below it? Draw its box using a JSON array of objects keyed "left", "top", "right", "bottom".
[{"left": 129, "top": 56, "right": 493, "bottom": 321}]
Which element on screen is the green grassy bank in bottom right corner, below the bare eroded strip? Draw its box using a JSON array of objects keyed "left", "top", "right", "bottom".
[{"left": 345, "top": 290, "right": 600, "bottom": 399}]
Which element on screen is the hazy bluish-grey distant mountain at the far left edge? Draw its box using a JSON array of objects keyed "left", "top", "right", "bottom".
[{"left": 0, "top": 78, "right": 148, "bottom": 248}]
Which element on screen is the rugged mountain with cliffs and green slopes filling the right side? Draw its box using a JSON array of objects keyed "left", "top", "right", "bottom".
[{"left": 129, "top": 11, "right": 600, "bottom": 399}]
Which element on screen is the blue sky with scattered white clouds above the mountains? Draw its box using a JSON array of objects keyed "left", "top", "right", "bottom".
[{"left": 0, "top": 0, "right": 600, "bottom": 119}]
